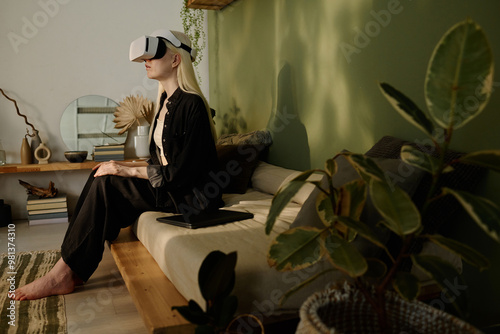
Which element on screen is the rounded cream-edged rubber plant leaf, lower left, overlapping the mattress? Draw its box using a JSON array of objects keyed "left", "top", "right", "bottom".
[{"left": 267, "top": 227, "right": 323, "bottom": 271}]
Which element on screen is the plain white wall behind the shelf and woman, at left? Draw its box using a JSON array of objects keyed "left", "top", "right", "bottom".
[{"left": 0, "top": 0, "right": 209, "bottom": 219}]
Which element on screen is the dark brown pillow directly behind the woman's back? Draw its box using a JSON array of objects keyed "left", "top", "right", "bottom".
[{"left": 216, "top": 144, "right": 266, "bottom": 194}]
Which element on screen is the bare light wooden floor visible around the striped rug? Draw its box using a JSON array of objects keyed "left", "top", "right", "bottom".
[{"left": 0, "top": 221, "right": 147, "bottom": 334}]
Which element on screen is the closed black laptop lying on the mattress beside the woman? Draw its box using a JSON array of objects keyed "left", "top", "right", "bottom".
[{"left": 156, "top": 209, "right": 253, "bottom": 229}]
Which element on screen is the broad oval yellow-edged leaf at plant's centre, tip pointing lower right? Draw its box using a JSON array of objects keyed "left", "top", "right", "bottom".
[{"left": 369, "top": 179, "right": 421, "bottom": 236}]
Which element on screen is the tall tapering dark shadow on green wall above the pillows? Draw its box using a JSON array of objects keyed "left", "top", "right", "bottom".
[{"left": 267, "top": 63, "right": 311, "bottom": 170}]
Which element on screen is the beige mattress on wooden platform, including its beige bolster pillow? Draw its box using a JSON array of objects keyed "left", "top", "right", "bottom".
[{"left": 134, "top": 163, "right": 338, "bottom": 315}]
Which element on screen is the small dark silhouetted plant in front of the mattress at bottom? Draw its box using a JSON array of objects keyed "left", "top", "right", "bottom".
[{"left": 172, "top": 251, "right": 238, "bottom": 334}]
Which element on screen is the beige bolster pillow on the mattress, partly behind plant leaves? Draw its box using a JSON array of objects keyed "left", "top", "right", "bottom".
[{"left": 252, "top": 161, "right": 321, "bottom": 204}]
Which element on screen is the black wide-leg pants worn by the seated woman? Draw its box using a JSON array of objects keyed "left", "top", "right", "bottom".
[{"left": 61, "top": 171, "right": 157, "bottom": 281}]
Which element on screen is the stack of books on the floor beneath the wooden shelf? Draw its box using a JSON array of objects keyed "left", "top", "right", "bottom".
[{"left": 26, "top": 194, "right": 68, "bottom": 225}]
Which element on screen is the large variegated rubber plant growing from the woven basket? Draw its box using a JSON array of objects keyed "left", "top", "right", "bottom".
[{"left": 266, "top": 20, "right": 500, "bottom": 326}]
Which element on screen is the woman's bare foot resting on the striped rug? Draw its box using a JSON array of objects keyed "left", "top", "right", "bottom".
[{"left": 12, "top": 258, "right": 83, "bottom": 300}]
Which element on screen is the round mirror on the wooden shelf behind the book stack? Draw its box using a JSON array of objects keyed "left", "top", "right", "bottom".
[{"left": 60, "top": 95, "right": 127, "bottom": 159}]
